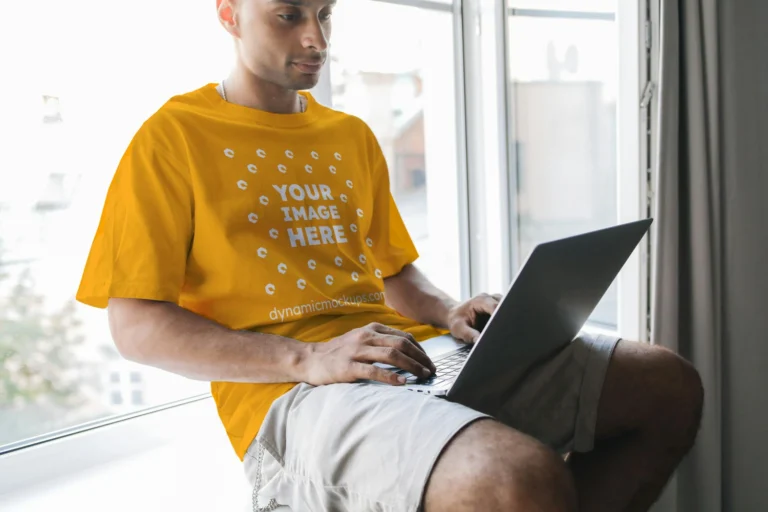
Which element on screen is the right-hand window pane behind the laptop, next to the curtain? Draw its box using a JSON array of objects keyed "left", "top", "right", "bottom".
[{"left": 507, "top": 0, "right": 639, "bottom": 329}]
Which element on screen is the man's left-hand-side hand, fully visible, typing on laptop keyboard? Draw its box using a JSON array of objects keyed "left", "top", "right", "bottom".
[{"left": 305, "top": 323, "right": 435, "bottom": 386}]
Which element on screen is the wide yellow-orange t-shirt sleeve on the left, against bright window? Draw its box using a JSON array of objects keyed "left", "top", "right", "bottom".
[{"left": 77, "top": 123, "right": 194, "bottom": 308}]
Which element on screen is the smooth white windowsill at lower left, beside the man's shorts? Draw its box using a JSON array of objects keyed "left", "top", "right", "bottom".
[{"left": 0, "top": 398, "right": 249, "bottom": 512}]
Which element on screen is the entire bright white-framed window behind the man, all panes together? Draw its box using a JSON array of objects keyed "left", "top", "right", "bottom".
[{"left": 0, "top": 0, "right": 642, "bottom": 456}]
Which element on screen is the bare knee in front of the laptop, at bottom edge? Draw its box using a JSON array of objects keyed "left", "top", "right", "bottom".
[{"left": 424, "top": 419, "right": 576, "bottom": 512}]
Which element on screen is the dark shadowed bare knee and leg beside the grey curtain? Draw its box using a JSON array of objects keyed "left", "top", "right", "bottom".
[{"left": 568, "top": 341, "right": 703, "bottom": 512}]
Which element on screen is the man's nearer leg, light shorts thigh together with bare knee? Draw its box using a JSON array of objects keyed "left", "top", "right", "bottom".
[{"left": 244, "top": 384, "right": 576, "bottom": 512}]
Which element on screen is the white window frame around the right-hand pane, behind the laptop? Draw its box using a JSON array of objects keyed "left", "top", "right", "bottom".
[{"left": 463, "top": 0, "right": 653, "bottom": 341}]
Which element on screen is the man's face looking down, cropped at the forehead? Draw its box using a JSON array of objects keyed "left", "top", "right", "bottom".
[{"left": 219, "top": 0, "right": 335, "bottom": 90}]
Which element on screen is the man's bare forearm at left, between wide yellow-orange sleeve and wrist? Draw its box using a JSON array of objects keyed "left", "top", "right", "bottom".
[{"left": 109, "top": 299, "right": 312, "bottom": 383}]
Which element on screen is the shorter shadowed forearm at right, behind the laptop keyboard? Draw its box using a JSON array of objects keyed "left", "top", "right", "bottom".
[{"left": 384, "top": 265, "right": 458, "bottom": 329}]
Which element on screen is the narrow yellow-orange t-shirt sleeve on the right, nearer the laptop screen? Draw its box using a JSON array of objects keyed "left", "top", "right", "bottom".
[{"left": 368, "top": 130, "right": 419, "bottom": 278}]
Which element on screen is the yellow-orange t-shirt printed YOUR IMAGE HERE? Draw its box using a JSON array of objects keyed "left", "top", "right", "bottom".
[{"left": 77, "top": 84, "right": 444, "bottom": 459}]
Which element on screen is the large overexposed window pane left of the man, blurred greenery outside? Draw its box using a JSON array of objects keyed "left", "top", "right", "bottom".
[{"left": 0, "top": 0, "right": 233, "bottom": 446}]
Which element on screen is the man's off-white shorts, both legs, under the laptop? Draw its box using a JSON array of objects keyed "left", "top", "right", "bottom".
[{"left": 244, "top": 335, "right": 619, "bottom": 512}]
